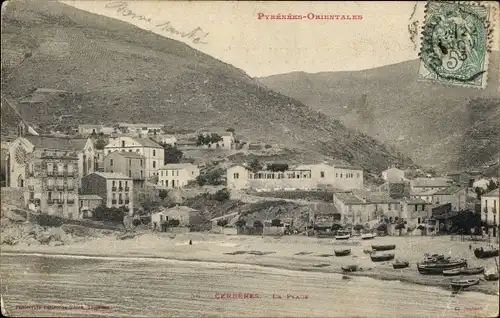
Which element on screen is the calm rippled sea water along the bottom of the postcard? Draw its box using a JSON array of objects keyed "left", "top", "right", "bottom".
[{"left": 0, "top": 253, "right": 498, "bottom": 317}]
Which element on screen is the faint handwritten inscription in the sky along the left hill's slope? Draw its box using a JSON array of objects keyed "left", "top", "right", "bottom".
[{"left": 105, "top": 1, "right": 209, "bottom": 44}]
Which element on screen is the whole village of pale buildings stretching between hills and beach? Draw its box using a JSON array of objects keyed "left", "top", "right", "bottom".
[{"left": 2, "top": 115, "right": 500, "bottom": 242}]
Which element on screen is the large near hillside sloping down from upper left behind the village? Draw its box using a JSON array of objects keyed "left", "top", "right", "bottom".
[{"left": 2, "top": 1, "right": 412, "bottom": 171}]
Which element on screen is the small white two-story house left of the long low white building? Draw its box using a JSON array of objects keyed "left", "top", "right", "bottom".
[{"left": 158, "top": 163, "right": 200, "bottom": 188}]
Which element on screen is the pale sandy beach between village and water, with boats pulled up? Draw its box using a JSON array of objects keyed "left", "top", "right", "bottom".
[{"left": 1, "top": 232, "right": 499, "bottom": 295}]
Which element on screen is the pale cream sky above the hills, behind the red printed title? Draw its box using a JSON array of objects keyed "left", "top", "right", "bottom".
[{"left": 61, "top": 0, "right": 500, "bottom": 77}]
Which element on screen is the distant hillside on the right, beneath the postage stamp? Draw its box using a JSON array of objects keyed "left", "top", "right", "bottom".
[{"left": 259, "top": 55, "right": 500, "bottom": 169}]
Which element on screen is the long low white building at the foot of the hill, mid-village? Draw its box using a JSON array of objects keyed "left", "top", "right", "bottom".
[{"left": 227, "top": 163, "right": 363, "bottom": 190}]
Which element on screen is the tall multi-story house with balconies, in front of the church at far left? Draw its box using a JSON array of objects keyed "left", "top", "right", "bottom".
[{"left": 24, "top": 149, "right": 81, "bottom": 219}]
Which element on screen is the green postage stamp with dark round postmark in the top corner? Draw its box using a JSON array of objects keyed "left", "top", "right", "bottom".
[{"left": 418, "top": 1, "right": 496, "bottom": 88}]
